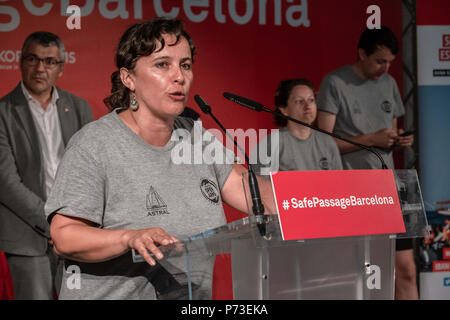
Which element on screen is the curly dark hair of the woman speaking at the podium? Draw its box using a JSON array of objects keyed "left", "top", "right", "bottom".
[{"left": 103, "top": 18, "right": 195, "bottom": 111}]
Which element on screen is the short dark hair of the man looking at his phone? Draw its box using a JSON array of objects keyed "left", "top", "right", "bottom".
[{"left": 358, "top": 26, "right": 398, "bottom": 56}]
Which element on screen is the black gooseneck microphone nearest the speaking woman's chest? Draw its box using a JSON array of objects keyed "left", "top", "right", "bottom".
[{"left": 194, "top": 94, "right": 266, "bottom": 237}]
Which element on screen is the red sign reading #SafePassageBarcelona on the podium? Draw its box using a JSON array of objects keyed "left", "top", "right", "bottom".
[{"left": 271, "top": 170, "right": 405, "bottom": 240}]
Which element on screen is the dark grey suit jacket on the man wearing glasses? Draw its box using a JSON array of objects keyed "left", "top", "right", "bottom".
[{"left": 0, "top": 83, "right": 93, "bottom": 256}]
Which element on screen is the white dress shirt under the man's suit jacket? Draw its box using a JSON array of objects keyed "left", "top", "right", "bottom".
[{"left": 21, "top": 82, "right": 64, "bottom": 196}]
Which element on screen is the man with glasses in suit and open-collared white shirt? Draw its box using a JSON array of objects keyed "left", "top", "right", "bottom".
[{"left": 0, "top": 32, "right": 93, "bottom": 299}]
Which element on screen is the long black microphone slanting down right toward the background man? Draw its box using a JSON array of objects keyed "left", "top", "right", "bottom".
[{"left": 223, "top": 92, "right": 388, "bottom": 169}]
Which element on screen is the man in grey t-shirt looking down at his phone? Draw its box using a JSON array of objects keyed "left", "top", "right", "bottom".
[{"left": 317, "top": 27, "right": 418, "bottom": 299}]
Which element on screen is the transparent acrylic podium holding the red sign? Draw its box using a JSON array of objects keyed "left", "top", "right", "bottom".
[{"left": 133, "top": 170, "right": 428, "bottom": 300}]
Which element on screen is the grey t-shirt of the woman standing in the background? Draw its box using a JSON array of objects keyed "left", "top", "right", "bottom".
[{"left": 252, "top": 128, "right": 342, "bottom": 174}]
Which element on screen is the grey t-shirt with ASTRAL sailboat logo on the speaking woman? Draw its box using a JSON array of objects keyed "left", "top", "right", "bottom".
[{"left": 45, "top": 111, "right": 232, "bottom": 299}]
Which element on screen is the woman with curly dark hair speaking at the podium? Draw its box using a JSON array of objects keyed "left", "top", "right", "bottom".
[{"left": 46, "top": 18, "right": 270, "bottom": 299}]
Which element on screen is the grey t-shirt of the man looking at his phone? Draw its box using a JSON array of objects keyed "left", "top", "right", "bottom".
[{"left": 317, "top": 65, "right": 405, "bottom": 169}]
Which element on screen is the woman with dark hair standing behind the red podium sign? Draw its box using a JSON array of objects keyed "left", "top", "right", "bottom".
[{"left": 252, "top": 79, "right": 342, "bottom": 174}]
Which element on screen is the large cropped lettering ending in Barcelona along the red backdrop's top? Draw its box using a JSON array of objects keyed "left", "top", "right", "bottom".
[{"left": 0, "top": 0, "right": 312, "bottom": 32}]
